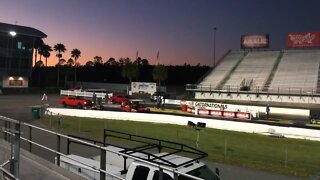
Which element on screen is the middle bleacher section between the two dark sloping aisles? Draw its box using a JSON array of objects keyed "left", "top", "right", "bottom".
[{"left": 225, "top": 51, "right": 280, "bottom": 89}]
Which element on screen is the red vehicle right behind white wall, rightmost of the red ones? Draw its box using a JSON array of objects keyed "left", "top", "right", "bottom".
[{"left": 121, "top": 99, "right": 150, "bottom": 112}]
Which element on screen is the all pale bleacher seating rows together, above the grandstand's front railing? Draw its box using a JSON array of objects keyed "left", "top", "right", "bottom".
[{"left": 200, "top": 49, "right": 320, "bottom": 93}]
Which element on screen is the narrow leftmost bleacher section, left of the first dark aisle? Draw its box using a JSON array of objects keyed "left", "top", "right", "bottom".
[{"left": 200, "top": 51, "right": 244, "bottom": 88}]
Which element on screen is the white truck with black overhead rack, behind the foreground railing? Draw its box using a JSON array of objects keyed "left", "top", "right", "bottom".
[{"left": 60, "top": 131, "right": 220, "bottom": 180}]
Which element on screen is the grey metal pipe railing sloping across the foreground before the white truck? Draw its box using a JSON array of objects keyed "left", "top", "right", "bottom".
[{"left": 0, "top": 116, "right": 212, "bottom": 180}]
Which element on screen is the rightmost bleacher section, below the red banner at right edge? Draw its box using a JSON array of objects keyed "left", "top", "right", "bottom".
[{"left": 269, "top": 50, "right": 320, "bottom": 92}]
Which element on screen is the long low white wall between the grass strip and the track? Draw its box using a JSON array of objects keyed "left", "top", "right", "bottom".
[{"left": 47, "top": 108, "right": 320, "bottom": 141}]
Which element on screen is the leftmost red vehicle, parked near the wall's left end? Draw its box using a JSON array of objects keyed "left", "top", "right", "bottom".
[{"left": 59, "top": 96, "right": 93, "bottom": 109}]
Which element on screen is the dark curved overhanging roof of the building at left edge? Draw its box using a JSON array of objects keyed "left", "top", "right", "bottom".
[{"left": 0, "top": 22, "right": 47, "bottom": 38}]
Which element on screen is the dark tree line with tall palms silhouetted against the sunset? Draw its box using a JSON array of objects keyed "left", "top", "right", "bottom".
[{"left": 30, "top": 41, "right": 209, "bottom": 88}]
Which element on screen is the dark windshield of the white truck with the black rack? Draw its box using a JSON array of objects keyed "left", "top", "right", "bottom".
[{"left": 178, "top": 166, "right": 220, "bottom": 180}]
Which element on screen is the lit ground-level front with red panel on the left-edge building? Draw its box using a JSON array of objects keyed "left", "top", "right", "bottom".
[{"left": 2, "top": 76, "right": 29, "bottom": 88}]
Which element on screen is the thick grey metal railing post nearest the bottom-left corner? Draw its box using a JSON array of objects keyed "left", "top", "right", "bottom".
[{"left": 10, "top": 122, "right": 21, "bottom": 179}]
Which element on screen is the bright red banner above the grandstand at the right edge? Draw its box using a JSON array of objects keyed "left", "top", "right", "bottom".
[{"left": 288, "top": 32, "right": 320, "bottom": 48}]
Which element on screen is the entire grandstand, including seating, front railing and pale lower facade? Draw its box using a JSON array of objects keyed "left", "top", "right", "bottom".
[{"left": 186, "top": 49, "right": 320, "bottom": 104}]
